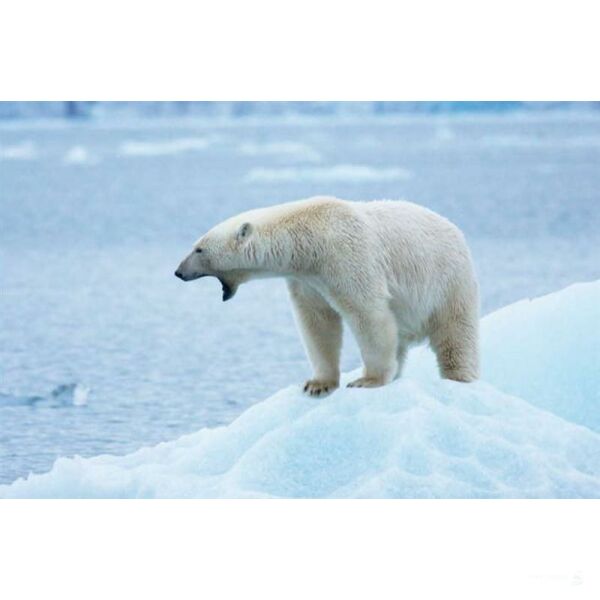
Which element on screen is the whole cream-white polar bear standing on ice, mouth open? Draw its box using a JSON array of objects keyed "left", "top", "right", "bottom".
[{"left": 175, "top": 197, "right": 479, "bottom": 396}]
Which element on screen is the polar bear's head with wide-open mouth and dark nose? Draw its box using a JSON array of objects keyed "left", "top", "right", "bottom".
[{"left": 175, "top": 218, "right": 256, "bottom": 301}]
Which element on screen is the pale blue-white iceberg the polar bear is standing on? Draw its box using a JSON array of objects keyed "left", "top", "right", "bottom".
[{"left": 0, "top": 282, "right": 600, "bottom": 498}]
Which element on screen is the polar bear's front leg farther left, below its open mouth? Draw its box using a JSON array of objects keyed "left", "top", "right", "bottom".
[{"left": 288, "top": 280, "right": 342, "bottom": 396}]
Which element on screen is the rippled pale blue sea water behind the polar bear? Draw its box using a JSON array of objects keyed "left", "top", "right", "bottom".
[{"left": 0, "top": 112, "right": 600, "bottom": 482}]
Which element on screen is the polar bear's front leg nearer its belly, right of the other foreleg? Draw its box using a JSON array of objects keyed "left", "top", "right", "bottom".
[{"left": 345, "top": 304, "right": 398, "bottom": 387}]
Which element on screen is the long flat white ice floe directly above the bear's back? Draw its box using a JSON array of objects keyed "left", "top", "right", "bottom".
[{"left": 246, "top": 164, "right": 412, "bottom": 183}]
